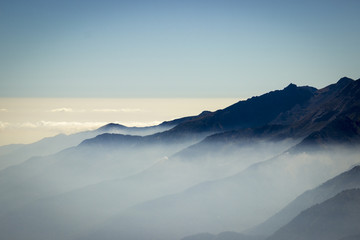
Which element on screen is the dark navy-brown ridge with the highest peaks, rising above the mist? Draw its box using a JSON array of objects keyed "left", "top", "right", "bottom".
[{"left": 168, "top": 77, "right": 360, "bottom": 142}]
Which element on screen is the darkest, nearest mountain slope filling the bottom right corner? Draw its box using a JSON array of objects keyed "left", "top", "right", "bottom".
[{"left": 268, "top": 189, "right": 360, "bottom": 240}]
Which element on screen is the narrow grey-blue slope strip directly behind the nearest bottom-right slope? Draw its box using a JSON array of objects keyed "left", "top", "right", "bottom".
[{"left": 248, "top": 165, "right": 360, "bottom": 236}]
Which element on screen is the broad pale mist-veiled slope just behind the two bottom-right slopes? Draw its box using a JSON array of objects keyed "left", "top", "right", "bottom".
[{"left": 82, "top": 149, "right": 359, "bottom": 240}]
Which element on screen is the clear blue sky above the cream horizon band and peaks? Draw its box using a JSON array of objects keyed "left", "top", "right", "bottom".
[{"left": 0, "top": 0, "right": 360, "bottom": 98}]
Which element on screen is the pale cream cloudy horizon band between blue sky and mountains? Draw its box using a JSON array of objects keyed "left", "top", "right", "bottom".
[{"left": 0, "top": 98, "right": 242, "bottom": 146}]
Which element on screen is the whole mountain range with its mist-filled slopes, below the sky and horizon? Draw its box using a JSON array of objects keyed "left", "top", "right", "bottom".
[{"left": 0, "top": 77, "right": 360, "bottom": 240}]
